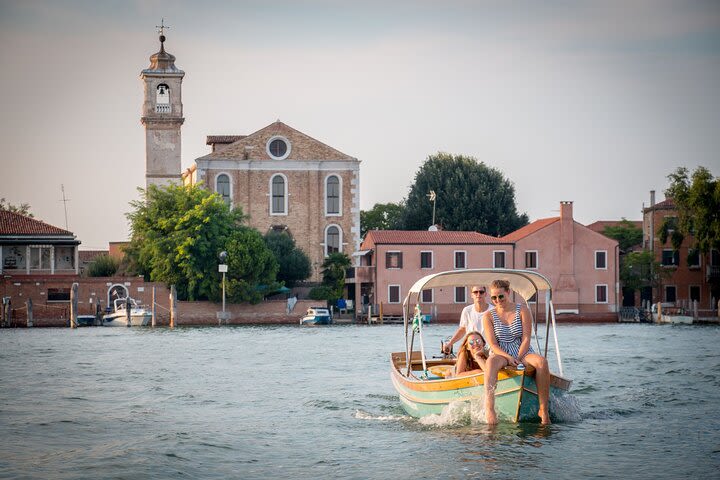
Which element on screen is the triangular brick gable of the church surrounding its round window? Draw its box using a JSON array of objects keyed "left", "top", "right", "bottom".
[{"left": 198, "top": 120, "right": 358, "bottom": 162}]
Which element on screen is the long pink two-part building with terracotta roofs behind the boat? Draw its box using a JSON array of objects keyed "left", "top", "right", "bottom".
[{"left": 347, "top": 202, "right": 619, "bottom": 321}]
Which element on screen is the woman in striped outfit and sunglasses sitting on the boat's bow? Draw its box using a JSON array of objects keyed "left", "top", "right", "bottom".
[{"left": 483, "top": 280, "right": 550, "bottom": 425}]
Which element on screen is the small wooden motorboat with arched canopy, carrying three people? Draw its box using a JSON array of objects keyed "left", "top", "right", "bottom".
[{"left": 390, "top": 269, "right": 572, "bottom": 422}]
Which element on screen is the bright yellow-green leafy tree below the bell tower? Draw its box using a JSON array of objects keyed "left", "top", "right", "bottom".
[{"left": 126, "top": 185, "right": 253, "bottom": 300}]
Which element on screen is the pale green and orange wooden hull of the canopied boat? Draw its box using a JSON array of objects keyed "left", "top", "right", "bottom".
[{"left": 391, "top": 352, "right": 569, "bottom": 423}]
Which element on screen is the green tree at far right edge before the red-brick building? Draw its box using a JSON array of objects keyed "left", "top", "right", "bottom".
[{"left": 661, "top": 167, "right": 720, "bottom": 254}]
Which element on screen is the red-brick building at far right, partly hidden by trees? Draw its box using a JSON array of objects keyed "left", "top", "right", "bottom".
[{"left": 643, "top": 191, "right": 720, "bottom": 309}]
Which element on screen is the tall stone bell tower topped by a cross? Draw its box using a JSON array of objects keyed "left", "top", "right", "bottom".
[{"left": 140, "top": 24, "right": 185, "bottom": 189}]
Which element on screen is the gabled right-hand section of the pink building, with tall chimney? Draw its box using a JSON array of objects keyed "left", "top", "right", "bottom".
[{"left": 502, "top": 202, "right": 620, "bottom": 320}]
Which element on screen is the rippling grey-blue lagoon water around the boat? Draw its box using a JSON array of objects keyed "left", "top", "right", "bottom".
[{"left": 0, "top": 324, "right": 720, "bottom": 479}]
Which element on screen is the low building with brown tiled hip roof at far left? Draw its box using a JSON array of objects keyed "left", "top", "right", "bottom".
[{"left": 0, "top": 210, "right": 80, "bottom": 275}]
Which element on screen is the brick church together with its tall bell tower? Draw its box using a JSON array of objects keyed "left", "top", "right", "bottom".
[{"left": 141, "top": 34, "right": 360, "bottom": 281}]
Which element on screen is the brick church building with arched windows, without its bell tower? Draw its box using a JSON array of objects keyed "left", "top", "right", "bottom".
[{"left": 183, "top": 121, "right": 360, "bottom": 281}]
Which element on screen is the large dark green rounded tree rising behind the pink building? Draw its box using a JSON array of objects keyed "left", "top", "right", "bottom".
[{"left": 402, "top": 152, "right": 528, "bottom": 236}]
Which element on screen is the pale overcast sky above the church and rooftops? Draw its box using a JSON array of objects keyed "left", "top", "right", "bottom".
[{"left": 0, "top": 0, "right": 720, "bottom": 249}]
